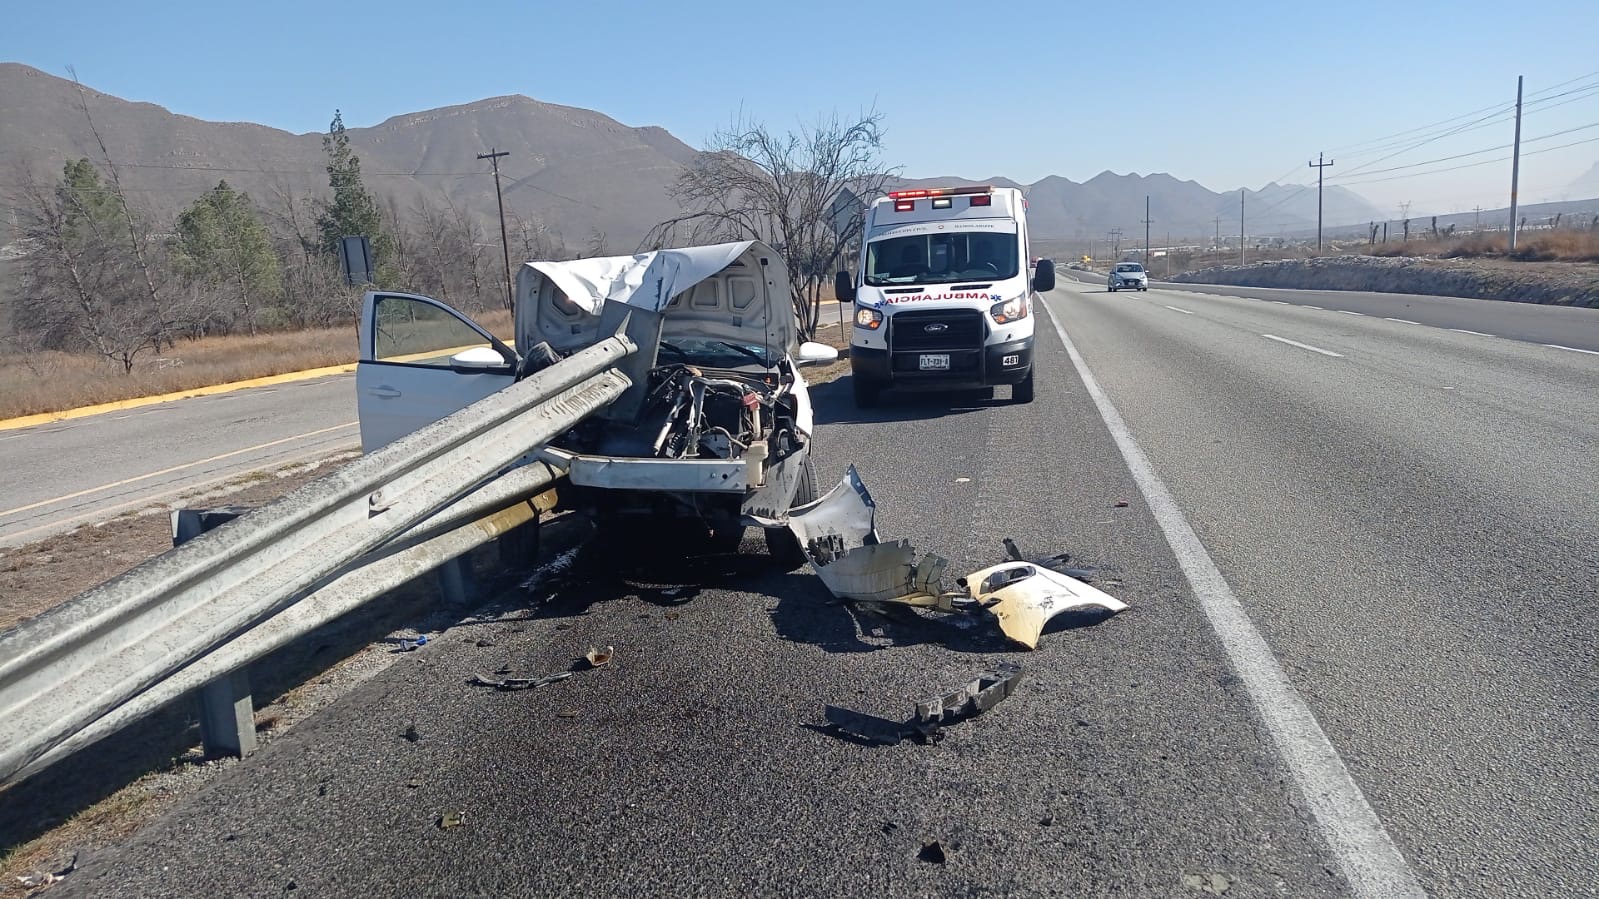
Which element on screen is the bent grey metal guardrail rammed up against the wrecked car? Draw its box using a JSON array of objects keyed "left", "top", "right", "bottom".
[{"left": 0, "top": 334, "right": 636, "bottom": 782}]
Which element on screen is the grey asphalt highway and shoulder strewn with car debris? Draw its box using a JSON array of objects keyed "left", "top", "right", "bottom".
[{"left": 28, "top": 275, "right": 1599, "bottom": 896}]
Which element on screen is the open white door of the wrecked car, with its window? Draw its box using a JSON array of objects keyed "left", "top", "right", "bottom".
[{"left": 355, "top": 291, "right": 518, "bottom": 453}]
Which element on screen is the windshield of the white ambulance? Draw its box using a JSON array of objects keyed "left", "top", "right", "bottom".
[{"left": 867, "top": 232, "right": 1022, "bottom": 286}]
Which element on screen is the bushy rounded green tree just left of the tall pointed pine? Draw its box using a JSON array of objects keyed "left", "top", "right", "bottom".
[{"left": 173, "top": 181, "right": 283, "bottom": 334}]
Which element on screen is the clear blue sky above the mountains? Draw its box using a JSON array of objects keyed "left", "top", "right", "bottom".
[{"left": 0, "top": 0, "right": 1599, "bottom": 214}]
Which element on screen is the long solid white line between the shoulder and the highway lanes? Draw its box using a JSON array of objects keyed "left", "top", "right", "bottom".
[{"left": 1049, "top": 302, "right": 1426, "bottom": 899}]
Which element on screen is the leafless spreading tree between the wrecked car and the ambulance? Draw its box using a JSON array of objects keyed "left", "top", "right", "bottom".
[{"left": 641, "top": 112, "right": 899, "bottom": 338}]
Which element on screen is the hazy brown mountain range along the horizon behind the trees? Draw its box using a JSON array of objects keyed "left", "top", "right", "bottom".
[{"left": 0, "top": 62, "right": 1383, "bottom": 251}]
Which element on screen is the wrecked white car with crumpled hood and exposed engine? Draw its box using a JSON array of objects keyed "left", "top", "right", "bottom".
[{"left": 357, "top": 242, "right": 838, "bottom": 568}]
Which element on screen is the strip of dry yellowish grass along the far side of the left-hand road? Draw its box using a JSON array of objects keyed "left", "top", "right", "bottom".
[{"left": 0, "top": 310, "right": 512, "bottom": 419}]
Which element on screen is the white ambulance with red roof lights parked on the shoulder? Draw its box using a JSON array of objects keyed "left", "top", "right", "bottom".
[{"left": 835, "top": 186, "right": 1055, "bottom": 406}]
